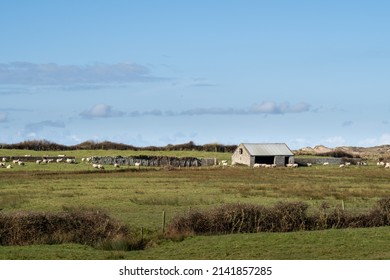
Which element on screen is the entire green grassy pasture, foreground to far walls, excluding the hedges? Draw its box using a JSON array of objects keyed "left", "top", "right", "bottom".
[{"left": 0, "top": 150, "right": 390, "bottom": 259}]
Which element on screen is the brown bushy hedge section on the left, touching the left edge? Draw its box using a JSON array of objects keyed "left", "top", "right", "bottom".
[{"left": 0, "top": 210, "right": 129, "bottom": 246}]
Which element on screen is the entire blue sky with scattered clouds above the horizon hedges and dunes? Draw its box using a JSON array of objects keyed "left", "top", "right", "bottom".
[{"left": 0, "top": 0, "right": 390, "bottom": 149}]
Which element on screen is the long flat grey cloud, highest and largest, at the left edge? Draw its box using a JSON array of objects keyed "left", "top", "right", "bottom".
[{"left": 0, "top": 62, "right": 157, "bottom": 86}]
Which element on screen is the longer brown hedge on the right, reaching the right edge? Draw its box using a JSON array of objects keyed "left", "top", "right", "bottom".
[{"left": 167, "top": 198, "right": 390, "bottom": 237}]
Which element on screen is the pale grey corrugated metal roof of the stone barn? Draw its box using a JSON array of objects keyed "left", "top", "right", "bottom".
[{"left": 242, "top": 143, "right": 294, "bottom": 156}]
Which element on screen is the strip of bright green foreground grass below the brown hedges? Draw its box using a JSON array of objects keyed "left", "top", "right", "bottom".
[{"left": 0, "top": 227, "right": 390, "bottom": 260}]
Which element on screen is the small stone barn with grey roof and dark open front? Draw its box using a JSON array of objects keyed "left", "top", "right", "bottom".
[{"left": 232, "top": 143, "right": 294, "bottom": 167}]
